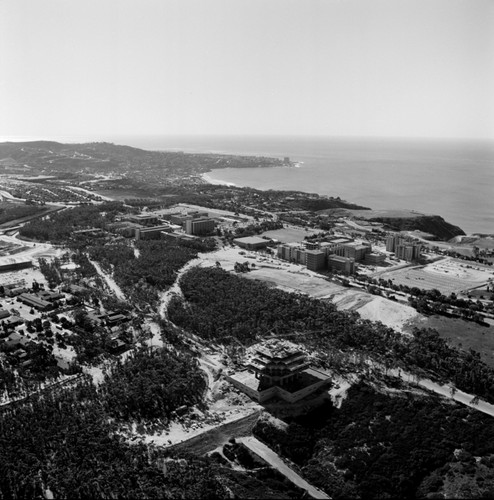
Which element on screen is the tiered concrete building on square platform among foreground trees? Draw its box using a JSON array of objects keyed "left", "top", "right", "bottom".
[{"left": 226, "top": 339, "right": 329, "bottom": 403}]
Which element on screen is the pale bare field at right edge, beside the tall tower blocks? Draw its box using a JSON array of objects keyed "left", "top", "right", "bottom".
[{"left": 380, "top": 258, "right": 494, "bottom": 295}]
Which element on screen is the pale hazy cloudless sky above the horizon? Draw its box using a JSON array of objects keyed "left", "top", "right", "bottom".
[{"left": 0, "top": 0, "right": 494, "bottom": 139}]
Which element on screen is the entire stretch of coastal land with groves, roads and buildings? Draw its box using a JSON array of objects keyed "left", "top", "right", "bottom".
[{"left": 0, "top": 142, "right": 494, "bottom": 498}]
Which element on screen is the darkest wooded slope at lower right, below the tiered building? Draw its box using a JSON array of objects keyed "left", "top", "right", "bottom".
[{"left": 254, "top": 383, "right": 494, "bottom": 498}]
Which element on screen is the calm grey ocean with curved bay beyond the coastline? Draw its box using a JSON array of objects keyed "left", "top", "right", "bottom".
[{"left": 31, "top": 136, "right": 494, "bottom": 234}]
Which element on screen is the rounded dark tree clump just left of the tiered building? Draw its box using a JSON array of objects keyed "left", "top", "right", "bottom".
[{"left": 100, "top": 349, "right": 206, "bottom": 420}]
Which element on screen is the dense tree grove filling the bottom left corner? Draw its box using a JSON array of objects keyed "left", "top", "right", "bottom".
[{"left": 0, "top": 381, "right": 224, "bottom": 498}]
